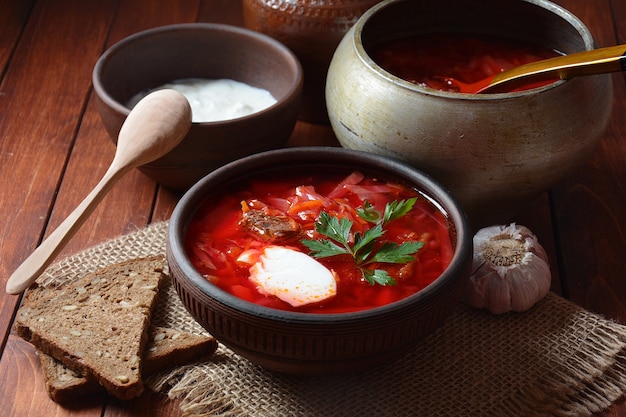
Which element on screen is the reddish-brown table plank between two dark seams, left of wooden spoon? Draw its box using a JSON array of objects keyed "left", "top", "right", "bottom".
[{"left": 0, "top": 0, "right": 113, "bottom": 352}]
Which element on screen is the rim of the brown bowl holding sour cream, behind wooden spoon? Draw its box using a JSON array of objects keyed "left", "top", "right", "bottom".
[{"left": 92, "top": 23, "right": 303, "bottom": 125}]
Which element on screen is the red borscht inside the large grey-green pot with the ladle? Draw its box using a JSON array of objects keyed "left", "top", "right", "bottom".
[{"left": 368, "top": 33, "right": 559, "bottom": 93}]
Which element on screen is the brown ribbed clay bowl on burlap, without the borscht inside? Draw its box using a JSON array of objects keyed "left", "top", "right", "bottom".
[{"left": 166, "top": 147, "right": 472, "bottom": 375}]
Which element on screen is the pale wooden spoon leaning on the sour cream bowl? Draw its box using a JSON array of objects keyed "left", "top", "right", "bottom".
[{"left": 6, "top": 90, "right": 191, "bottom": 294}]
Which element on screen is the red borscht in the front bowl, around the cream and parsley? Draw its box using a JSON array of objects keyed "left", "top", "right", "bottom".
[{"left": 185, "top": 172, "right": 454, "bottom": 313}]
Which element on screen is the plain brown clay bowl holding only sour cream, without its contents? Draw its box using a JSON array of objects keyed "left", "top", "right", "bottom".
[{"left": 93, "top": 23, "right": 302, "bottom": 191}]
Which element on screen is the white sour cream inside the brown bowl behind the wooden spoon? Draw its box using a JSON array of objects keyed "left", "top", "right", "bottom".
[{"left": 126, "top": 78, "right": 276, "bottom": 123}]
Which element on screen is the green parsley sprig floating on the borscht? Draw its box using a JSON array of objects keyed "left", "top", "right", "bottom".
[{"left": 301, "top": 198, "right": 424, "bottom": 285}]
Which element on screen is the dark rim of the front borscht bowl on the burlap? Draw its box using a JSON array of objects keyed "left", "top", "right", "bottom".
[{"left": 167, "top": 146, "right": 473, "bottom": 324}]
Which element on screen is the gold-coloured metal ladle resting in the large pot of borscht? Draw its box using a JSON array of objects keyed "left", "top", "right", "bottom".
[{"left": 448, "top": 45, "right": 626, "bottom": 94}]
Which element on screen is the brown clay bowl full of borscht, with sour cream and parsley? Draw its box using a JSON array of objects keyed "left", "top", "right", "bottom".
[{"left": 166, "top": 147, "right": 472, "bottom": 375}]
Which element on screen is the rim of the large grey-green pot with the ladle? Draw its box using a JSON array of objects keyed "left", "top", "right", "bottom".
[{"left": 352, "top": 0, "right": 595, "bottom": 100}]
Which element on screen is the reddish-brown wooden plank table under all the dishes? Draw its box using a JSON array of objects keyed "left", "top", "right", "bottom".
[{"left": 0, "top": 0, "right": 626, "bottom": 417}]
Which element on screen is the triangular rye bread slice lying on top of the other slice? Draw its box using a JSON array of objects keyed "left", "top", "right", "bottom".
[{"left": 15, "top": 256, "right": 165, "bottom": 399}]
